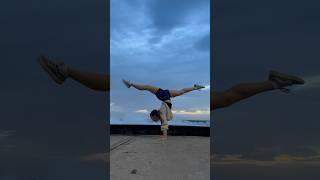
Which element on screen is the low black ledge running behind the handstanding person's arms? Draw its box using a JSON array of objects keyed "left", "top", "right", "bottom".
[{"left": 110, "top": 125, "right": 210, "bottom": 137}]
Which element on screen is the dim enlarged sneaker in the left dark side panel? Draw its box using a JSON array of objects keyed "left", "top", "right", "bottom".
[{"left": 38, "top": 56, "right": 67, "bottom": 84}]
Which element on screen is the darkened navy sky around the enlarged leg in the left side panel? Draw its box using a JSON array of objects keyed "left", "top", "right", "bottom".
[{"left": 0, "top": 0, "right": 109, "bottom": 180}]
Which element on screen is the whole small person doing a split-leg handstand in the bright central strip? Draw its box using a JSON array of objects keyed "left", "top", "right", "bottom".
[{"left": 123, "top": 80, "right": 205, "bottom": 138}]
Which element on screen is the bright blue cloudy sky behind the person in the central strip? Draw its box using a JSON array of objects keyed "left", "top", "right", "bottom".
[{"left": 110, "top": 0, "right": 210, "bottom": 124}]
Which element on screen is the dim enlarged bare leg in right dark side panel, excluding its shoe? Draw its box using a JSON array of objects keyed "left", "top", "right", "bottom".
[{"left": 210, "top": 81, "right": 274, "bottom": 110}]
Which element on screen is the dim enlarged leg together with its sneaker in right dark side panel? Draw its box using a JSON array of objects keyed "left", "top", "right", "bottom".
[{"left": 210, "top": 71, "right": 305, "bottom": 111}]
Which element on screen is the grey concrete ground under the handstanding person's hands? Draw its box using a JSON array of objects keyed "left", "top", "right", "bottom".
[{"left": 110, "top": 135, "right": 210, "bottom": 180}]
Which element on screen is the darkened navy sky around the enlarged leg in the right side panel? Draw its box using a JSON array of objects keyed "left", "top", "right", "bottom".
[{"left": 211, "top": 0, "right": 320, "bottom": 180}]
